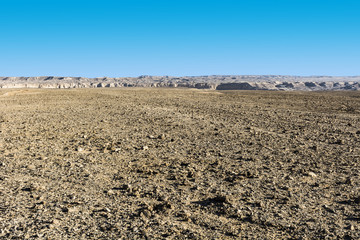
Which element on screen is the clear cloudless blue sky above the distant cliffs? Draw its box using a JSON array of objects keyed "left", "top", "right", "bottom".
[{"left": 0, "top": 0, "right": 360, "bottom": 77}]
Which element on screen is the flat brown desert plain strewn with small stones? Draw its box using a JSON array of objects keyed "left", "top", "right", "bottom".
[{"left": 0, "top": 88, "right": 360, "bottom": 239}]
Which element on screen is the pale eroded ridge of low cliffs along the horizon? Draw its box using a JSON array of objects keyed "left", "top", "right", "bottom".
[{"left": 0, "top": 75, "right": 360, "bottom": 91}]
